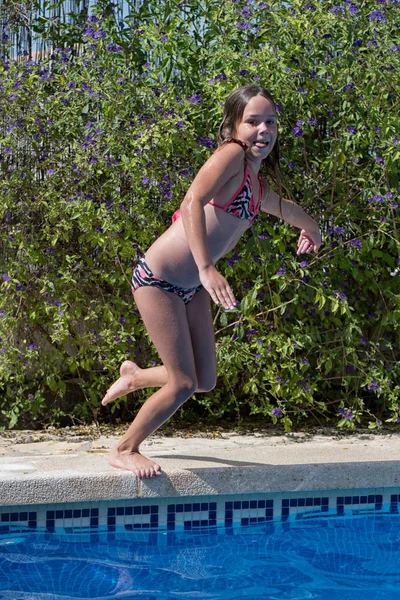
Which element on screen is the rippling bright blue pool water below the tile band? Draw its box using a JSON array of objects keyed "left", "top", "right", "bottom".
[{"left": 0, "top": 507, "right": 400, "bottom": 600}]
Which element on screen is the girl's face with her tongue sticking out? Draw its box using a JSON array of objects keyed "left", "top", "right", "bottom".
[{"left": 234, "top": 96, "right": 278, "bottom": 161}]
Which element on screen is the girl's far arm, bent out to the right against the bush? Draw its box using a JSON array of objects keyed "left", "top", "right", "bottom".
[{"left": 260, "top": 185, "right": 321, "bottom": 254}]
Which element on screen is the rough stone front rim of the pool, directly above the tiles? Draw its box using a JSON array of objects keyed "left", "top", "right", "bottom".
[{"left": 0, "top": 461, "right": 400, "bottom": 506}]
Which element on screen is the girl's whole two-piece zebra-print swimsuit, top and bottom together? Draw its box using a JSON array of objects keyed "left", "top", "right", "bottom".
[{"left": 132, "top": 146, "right": 263, "bottom": 304}]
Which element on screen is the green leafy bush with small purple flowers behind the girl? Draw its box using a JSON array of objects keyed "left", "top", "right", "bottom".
[{"left": 0, "top": 0, "right": 400, "bottom": 430}]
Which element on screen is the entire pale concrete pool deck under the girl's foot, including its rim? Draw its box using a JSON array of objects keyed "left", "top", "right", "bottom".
[{"left": 0, "top": 432, "right": 400, "bottom": 506}]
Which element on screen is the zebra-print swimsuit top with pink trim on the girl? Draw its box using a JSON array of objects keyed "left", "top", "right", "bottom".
[{"left": 172, "top": 160, "right": 263, "bottom": 225}]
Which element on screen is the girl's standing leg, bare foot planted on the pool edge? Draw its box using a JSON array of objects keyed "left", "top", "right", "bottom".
[{"left": 109, "top": 287, "right": 197, "bottom": 477}]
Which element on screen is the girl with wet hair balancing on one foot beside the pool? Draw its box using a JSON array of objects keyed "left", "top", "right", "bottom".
[{"left": 102, "top": 85, "right": 321, "bottom": 477}]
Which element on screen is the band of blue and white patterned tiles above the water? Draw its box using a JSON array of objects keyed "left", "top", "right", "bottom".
[{"left": 0, "top": 487, "right": 400, "bottom": 536}]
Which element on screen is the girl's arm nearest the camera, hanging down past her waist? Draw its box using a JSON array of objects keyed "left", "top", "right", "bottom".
[{"left": 181, "top": 144, "right": 244, "bottom": 308}]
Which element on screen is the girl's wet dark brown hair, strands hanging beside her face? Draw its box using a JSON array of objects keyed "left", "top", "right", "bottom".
[{"left": 217, "top": 84, "right": 292, "bottom": 218}]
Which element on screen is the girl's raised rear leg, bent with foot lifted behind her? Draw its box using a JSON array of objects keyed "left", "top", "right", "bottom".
[{"left": 101, "top": 288, "right": 216, "bottom": 406}]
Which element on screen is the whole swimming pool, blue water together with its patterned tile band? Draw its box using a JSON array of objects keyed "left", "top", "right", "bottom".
[{"left": 0, "top": 488, "right": 400, "bottom": 600}]
